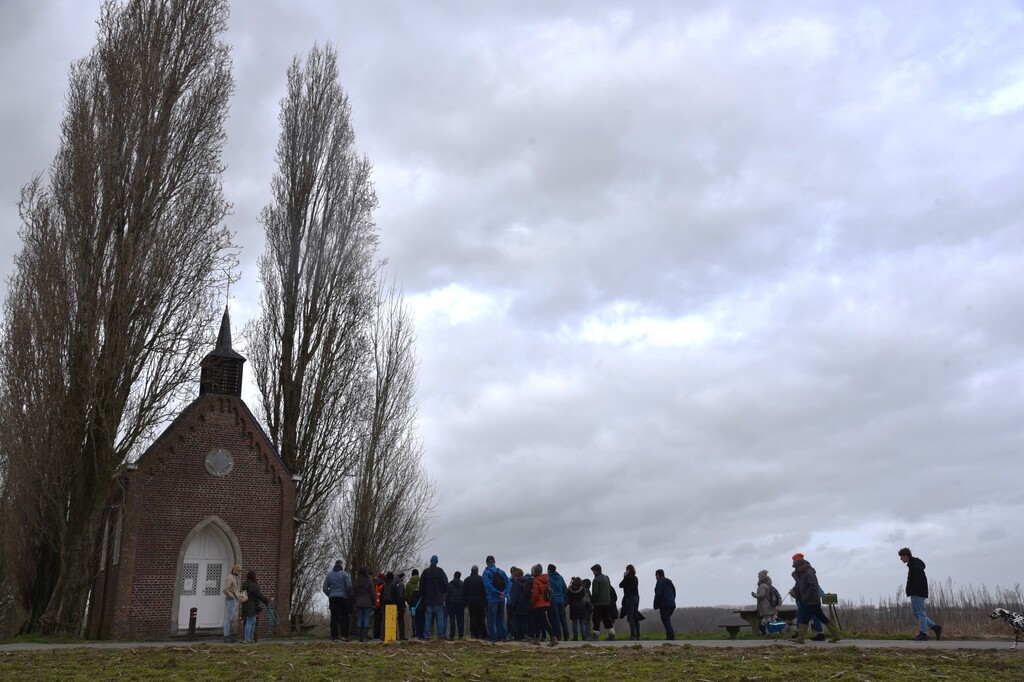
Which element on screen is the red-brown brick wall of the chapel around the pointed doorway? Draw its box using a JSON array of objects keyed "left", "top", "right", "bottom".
[{"left": 90, "top": 394, "right": 295, "bottom": 639}]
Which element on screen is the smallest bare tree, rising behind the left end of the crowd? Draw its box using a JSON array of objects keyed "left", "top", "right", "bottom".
[{"left": 334, "top": 284, "right": 435, "bottom": 570}]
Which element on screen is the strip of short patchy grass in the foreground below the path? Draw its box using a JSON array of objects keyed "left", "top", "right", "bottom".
[{"left": 0, "top": 643, "right": 1024, "bottom": 682}]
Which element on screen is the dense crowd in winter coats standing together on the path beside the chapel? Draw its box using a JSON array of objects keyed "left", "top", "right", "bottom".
[{"left": 323, "top": 555, "right": 676, "bottom": 646}]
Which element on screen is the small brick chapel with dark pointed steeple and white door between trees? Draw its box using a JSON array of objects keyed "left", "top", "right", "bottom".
[{"left": 86, "top": 309, "right": 297, "bottom": 639}]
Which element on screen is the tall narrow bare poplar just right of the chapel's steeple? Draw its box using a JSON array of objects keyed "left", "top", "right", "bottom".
[{"left": 246, "top": 45, "right": 377, "bottom": 613}]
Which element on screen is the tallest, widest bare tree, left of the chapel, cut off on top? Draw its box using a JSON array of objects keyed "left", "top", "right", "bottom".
[{"left": 0, "top": 0, "right": 233, "bottom": 632}]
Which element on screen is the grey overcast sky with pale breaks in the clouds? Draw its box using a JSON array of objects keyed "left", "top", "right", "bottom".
[{"left": 0, "top": 0, "right": 1024, "bottom": 606}]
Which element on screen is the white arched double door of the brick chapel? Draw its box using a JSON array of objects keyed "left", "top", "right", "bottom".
[{"left": 178, "top": 525, "right": 231, "bottom": 630}]
